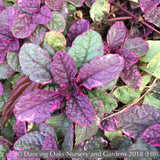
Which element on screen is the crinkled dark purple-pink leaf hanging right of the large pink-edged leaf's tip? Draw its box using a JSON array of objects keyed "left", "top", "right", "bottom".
[{"left": 120, "top": 65, "right": 142, "bottom": 89}]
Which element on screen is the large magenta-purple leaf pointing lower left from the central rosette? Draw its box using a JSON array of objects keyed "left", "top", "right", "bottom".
[{"left": 13, "top": 89, "right": 62, "bottom": 123}]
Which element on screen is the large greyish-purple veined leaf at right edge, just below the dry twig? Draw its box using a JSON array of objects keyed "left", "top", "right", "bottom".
[{"left": 115, "top": 105, "right": 160, "bottom": 139}]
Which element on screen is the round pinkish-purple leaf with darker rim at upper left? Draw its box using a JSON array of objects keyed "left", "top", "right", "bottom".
[{"left": 12, "top": 14, "right": 37, "bottom": 39}]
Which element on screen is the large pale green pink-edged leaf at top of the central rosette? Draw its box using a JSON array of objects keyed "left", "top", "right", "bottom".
[{"left": 68, "top": 30, "right": 104, "bottom": 68}]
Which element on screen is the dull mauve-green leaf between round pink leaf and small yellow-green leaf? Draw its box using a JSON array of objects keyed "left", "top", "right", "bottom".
[{"left": 29, "top": 25, "right": 47, "bottom": 45}]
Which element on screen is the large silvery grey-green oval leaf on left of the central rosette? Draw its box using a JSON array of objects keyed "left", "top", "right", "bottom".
[{"left": 19, "top": 43, "right": 52, "bottom": 83}]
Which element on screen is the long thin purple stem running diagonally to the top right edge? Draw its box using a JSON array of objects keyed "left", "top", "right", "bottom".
[{"left": 110, "top": 2, "right": 160, "bottom": 34}]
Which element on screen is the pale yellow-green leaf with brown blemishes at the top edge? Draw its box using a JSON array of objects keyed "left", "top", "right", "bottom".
[{"left": 90, "top": 0, "right": 110, "bottom": 21}]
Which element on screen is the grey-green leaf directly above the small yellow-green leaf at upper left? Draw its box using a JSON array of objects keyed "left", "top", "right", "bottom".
[{"left": 45, "top": 11, "right": 66, "bottom": 32}]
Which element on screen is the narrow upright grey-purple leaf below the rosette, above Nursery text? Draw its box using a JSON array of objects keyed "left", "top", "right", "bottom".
[{"left": 62, "top": 122, "right": 74, "bottom": 151}]
